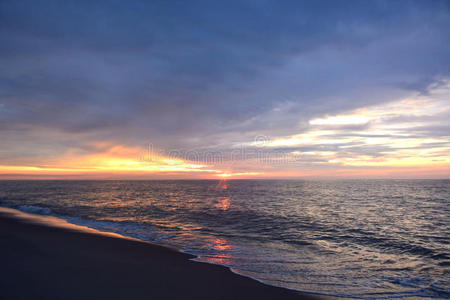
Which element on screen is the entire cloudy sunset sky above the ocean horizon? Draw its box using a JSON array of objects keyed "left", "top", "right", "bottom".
[{"left": 0, "top": 0, "right": 450, "bottom": 179}]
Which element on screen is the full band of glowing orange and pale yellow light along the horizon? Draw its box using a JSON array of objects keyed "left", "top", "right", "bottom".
[{"left": 0, "top": 85, "right": 450, "bottom": 179}]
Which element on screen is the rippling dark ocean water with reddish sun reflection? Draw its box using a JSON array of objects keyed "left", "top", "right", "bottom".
[{"left": 0, "top": 180, "right": 450, "bottom": 299}]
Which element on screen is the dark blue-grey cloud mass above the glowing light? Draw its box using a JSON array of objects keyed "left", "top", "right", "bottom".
[{"left": 0, "top": 1, "right": 450, "bottom": 159}]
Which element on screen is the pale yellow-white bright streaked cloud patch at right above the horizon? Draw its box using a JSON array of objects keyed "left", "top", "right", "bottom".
[{"left": 251, "top": 87, "right": 450, "bottom": 173}]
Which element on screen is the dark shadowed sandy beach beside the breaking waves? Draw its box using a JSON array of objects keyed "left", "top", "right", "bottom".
[{"left": 0, "top": 209, "right": 326, "bottom": 300}]
